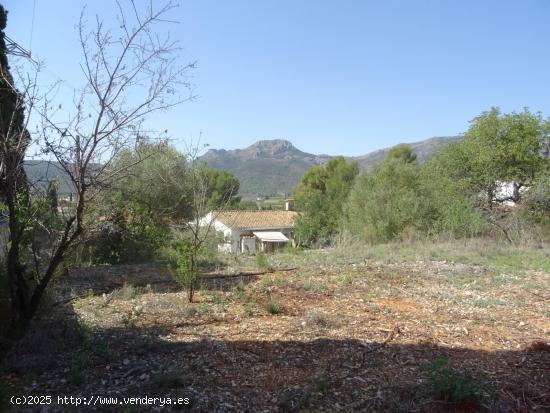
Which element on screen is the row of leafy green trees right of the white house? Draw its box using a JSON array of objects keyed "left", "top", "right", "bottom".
[{"left": 294, "top": 108, "right": 550, "bottom": 245}]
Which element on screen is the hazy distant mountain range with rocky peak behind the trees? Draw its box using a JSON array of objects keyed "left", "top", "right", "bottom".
[{"left": 201, "top": 136, "right": 461, "bottom": 198}]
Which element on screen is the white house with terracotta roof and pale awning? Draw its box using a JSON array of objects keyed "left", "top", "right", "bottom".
[{"left": 200, "top": 210, "right": 297, "bottom": 254}]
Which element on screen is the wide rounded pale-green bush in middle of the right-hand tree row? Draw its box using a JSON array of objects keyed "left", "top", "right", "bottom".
[{"left": 345, "top": 157, "right": 483, "bottom": 242}]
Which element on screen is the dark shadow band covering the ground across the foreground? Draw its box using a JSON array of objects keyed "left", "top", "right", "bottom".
[{"left": 0, "top": 305, "right": 550, "bottom": 412}]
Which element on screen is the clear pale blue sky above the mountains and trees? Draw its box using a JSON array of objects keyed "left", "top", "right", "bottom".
[{"left": 0, "top": 0, "right": 550, "bottom": 155}]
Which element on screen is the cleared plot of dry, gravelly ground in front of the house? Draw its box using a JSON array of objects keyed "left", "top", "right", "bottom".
[{"left": 3, "top": 243, "right": 550, "bottom": 412}]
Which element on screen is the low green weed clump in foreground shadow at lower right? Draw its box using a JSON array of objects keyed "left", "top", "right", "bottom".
[{"left": 428, "top": 358, "right": 490, "bottom": 407}]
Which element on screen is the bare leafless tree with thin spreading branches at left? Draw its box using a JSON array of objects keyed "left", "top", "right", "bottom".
[{"left": 1, "top": 1, "right": 193, "bottom": 327}]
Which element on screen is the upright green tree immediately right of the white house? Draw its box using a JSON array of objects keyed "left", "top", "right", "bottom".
[{"left": 294, "top": 157, "right": 359, "bottom": 245}]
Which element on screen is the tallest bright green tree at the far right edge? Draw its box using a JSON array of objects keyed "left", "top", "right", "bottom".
[{"left": 431, "top": 108, "right": 549, "bottom": 205}]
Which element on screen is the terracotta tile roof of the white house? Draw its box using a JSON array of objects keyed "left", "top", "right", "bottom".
[{"left": 215, "top": 211, "right": 298, "bottom": 229}]
